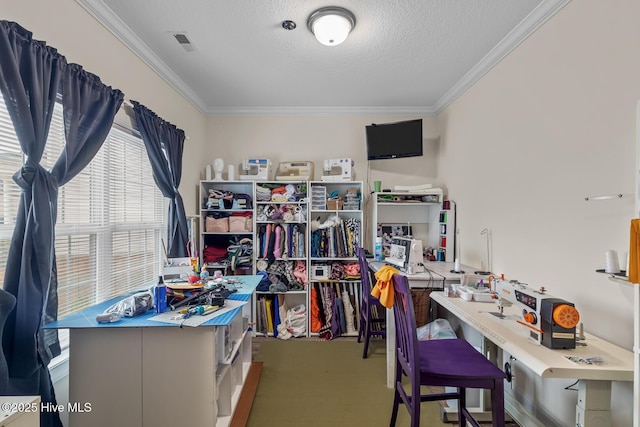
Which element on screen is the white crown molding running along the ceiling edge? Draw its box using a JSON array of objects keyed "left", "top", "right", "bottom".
[{"left": 76, "top": 0, "right": 571, "bottom": 116}]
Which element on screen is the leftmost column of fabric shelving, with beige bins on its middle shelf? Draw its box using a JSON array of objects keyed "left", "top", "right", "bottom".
[{"left": 199, "top": 181, "right": 255, "bottom": 275}]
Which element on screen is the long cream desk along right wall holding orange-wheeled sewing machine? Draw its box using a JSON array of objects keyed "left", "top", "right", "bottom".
[{"left": 431, "top": 292, "right": 633, "bottom": 427}]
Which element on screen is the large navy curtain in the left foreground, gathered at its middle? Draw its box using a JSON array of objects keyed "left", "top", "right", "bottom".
[{"left": 0, "top": 21, "right": 124, "bottom": 426}]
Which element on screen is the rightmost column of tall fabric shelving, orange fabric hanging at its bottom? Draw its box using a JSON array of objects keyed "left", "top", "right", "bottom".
[{"left": 309, "top": 181, "right": 363, "bottom": 339}]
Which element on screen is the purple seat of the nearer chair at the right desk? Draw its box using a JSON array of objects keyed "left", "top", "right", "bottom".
[{"left": 418, "top": 339, "right": 505, "bottom": 388}]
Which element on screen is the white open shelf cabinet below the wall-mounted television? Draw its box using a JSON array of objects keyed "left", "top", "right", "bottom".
[{"left": 370, "top": 188, "right": 455, "bottom": 262}]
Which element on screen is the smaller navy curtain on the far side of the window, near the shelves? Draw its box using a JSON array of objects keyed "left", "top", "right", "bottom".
[{"left": 131, "top": 101, "right": 188, "bottom": 258}]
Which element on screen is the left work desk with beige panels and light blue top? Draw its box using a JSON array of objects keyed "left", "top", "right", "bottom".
[{"left": 45, "top": 276, "right": 261, "bottom": 427}]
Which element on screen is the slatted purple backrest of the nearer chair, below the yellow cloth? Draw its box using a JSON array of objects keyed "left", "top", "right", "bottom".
[{"left": 393, "top": 274, "right": 420, "bottom": 384}]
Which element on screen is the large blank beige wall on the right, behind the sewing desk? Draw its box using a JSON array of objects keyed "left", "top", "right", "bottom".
[{"left": 438, "top": 0, "right": 640, "bottom": 426}]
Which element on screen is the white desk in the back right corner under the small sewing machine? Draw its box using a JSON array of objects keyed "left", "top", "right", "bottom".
[{"left": 369, "top": 261, "right": 475, "bottom": 388}]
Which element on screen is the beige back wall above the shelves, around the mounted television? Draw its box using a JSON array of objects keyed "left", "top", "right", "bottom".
[{"left": 205, "top": 116, "right": 443, "bottom": 249}]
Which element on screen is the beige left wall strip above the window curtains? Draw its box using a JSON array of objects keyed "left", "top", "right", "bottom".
[{"left": 0, "top": 0, "right": 205, "bottom": 215}]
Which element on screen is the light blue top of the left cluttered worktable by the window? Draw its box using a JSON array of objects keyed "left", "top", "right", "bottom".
[{"left": 42, "top": 276, "right": 262, "bottom": 329}]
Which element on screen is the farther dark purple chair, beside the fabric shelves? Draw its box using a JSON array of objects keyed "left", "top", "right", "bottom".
[{"left": 356, "top": 248, "right": 387, "bottom": 359}]
